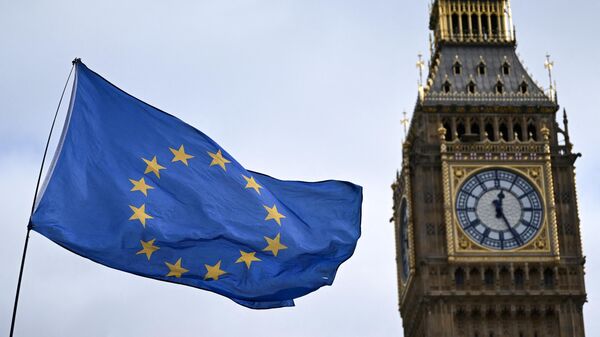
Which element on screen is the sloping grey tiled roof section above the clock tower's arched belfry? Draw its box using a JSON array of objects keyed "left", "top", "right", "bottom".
[{"left": 421, "top": 44, "right": 556, "bottom": 107}]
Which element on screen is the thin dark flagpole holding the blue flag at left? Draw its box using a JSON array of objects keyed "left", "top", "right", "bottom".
[{"left": 9, "top": 58, "right": 81, "bottom": 337}]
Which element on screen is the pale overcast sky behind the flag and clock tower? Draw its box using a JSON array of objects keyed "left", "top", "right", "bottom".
[{"left": 0, "top": 0, "right": 600, "bottom": 337}]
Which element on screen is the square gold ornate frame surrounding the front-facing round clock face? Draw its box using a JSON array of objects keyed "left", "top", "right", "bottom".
[{"left": 441, "top": 127, "right": 560, "bottom": 262}]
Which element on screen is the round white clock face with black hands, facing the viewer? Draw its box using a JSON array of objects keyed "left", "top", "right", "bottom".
[{"left": 456, "top": 169, "right": 544, "bottom": 250}]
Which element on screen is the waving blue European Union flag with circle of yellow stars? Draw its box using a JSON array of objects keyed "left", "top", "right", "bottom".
[{"left": 30, "top": 62, "right": 362, "bottom": 308}]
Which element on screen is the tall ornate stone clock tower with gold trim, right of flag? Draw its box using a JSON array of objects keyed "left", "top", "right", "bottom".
[{"left": 392, "top": 0, "right": 586, "bottom": 337}]
